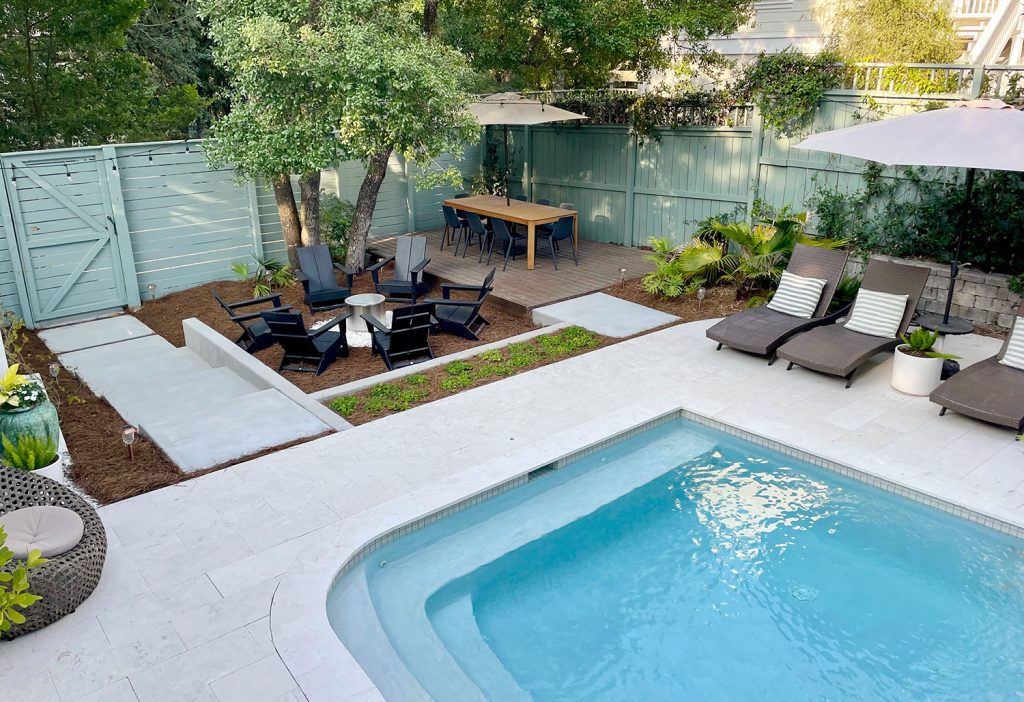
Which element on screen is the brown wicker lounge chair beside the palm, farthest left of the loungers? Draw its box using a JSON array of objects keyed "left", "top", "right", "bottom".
[{"left": 705, "top": 244, "right": 849, "bottom": 365}]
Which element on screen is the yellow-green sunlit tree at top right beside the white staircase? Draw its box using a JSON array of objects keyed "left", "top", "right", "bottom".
[{"left": 828, "top": 0, "right": 962, "bottom": 63}]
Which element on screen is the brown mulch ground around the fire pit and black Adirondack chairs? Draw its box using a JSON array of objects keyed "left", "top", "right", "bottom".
[{"left": 133, "top": 273, "right": 537, "bottom": 392}]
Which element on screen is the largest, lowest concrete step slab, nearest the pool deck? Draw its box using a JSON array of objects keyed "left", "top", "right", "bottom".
[{"left": 140, "top": 390, "right": 331, "bottom": 473}]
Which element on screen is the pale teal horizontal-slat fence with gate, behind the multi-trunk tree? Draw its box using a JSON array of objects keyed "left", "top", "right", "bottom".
[{"left": 0, "top": 142, "right": 480, "bottom": 325}]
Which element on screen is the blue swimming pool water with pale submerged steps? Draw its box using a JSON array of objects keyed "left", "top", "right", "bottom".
[{"left": 328, "top": 421, "right": 1024, "bottom": 702}]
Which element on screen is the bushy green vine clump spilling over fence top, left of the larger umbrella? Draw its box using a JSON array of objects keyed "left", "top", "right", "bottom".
[{"left": 737, "top": 47, "right": 844, "bottom": 133}]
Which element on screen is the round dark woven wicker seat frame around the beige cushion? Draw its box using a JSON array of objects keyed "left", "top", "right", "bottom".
[{"left": 0, "top": 466, "right": 106, "bottom": 639}]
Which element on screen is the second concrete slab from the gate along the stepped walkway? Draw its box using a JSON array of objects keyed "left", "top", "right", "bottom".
[{"left": 59, "top": 336, "right": 210, "bottom": 397}]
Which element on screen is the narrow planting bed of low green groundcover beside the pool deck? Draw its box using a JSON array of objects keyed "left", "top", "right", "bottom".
[{"left": 328, "top": 326, "right": 606, "bottom": 425}]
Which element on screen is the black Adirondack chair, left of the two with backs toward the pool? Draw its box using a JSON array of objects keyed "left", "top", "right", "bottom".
[{"left": 262, "top": 310, "right": 352, "bottom": 376}]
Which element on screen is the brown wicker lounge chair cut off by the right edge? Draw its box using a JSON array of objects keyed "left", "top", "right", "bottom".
[{"left": 929, "top": 303, "right": 1024, "bottom": 434}]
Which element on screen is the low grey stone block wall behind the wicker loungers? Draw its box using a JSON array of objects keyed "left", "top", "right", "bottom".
[{"left": 846, "top": 256, "right": 1021, "bottom": 330}]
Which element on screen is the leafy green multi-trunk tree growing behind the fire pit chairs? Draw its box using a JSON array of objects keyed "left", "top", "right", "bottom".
[{"left": 201, "top": 0, "right": 478, "bottom": 269}]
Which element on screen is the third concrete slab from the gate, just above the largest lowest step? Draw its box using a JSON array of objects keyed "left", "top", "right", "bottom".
[{"left": 106, "top": 367, "right": 258, "bottom": 427}]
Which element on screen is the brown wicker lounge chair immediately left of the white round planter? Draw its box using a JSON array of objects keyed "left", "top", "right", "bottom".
[{"left": 777, "top": 259, "right": 929, "bottom": 388}]
